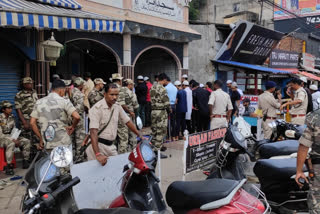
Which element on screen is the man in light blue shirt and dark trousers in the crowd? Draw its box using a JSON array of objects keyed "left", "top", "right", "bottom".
[{"left": 165, "top": 77, "right": 178, "bottom": 140}]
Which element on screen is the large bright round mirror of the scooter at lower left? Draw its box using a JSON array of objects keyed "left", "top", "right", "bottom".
[{"left": 50, "top": 146, "right": 72, "bottom": 167}]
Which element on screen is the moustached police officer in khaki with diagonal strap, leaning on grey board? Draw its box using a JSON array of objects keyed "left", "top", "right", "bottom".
[{"left": 86, "top": 84, "right": 141, "bottom": 165}]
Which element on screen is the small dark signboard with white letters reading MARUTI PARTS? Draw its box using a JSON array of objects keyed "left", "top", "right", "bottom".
[{"left": 269, "top": 50, "right": 299, "bottom": 68}]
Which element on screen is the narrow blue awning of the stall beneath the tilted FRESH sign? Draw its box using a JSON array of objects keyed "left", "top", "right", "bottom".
[{"left": 212, "top": 60, "right": 292, "bottom": 74}]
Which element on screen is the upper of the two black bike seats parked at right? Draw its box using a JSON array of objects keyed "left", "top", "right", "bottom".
[{"left": 259, "top": 140, "right": 299, "bottom": 159}]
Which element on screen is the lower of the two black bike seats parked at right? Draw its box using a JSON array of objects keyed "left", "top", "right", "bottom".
[{"left": 253, "top": 158, "right": 307, "bottom": 180}]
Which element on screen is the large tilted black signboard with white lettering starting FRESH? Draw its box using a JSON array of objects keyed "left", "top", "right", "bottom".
[{"left": 215, "top": 21, "right": 283, "bottom": 65}]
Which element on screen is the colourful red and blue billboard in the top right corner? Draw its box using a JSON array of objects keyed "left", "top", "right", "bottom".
[{"left": 274, "top": 0, "right": 320, "bottom": 20}]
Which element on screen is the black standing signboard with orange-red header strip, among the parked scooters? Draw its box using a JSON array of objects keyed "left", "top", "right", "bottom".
[{"left": 185, "top": 128, "right": 227, "bottom": 173}]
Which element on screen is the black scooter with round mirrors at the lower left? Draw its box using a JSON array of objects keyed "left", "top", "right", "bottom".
[{"left": 20, "top": 126, "right": 148, "bottom": 214}]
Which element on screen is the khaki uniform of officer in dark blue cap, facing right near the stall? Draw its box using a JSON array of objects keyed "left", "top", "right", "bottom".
[{"left": 258, "top": 91, "right": 280, "bottom": 139}]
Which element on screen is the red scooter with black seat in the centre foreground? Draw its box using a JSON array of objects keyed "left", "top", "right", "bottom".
[{"left": 109, "top": 134, "right": 269, "bottom": 214}]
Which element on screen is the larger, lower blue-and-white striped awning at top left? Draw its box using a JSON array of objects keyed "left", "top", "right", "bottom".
[{"left": 0, "top": 0, "right": 124, "bottom": 33}]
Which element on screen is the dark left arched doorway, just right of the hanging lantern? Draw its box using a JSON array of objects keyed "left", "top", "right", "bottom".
[{"left": 55, "top": 39, "right": 120, "bottom": 81}]
